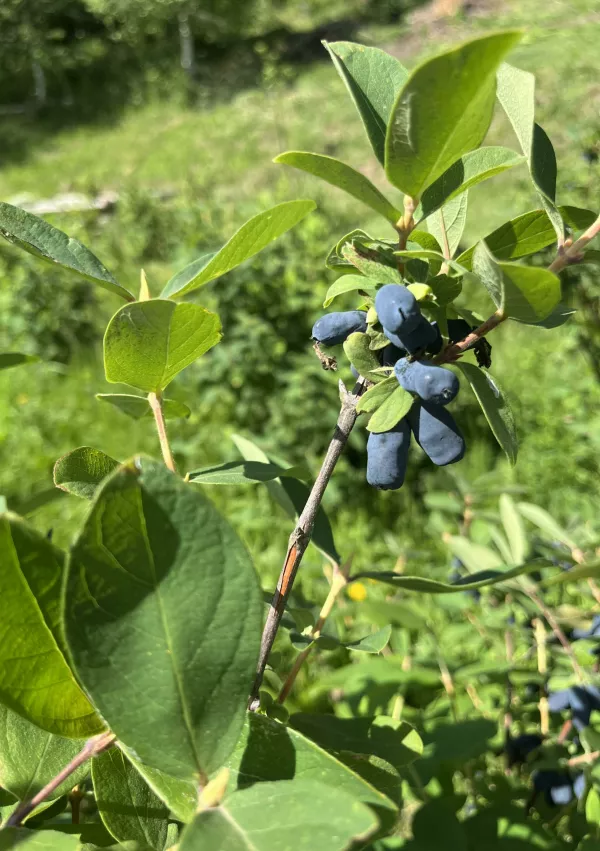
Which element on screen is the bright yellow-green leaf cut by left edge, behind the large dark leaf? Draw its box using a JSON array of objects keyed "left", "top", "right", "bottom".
[{"left": 0, "top": 514, "right": 105, "bottom": 738}]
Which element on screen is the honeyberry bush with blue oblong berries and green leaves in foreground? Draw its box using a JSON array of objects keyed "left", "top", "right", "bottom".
[{"left": 0, "top": 32, "right": 600, "bottom": 851}]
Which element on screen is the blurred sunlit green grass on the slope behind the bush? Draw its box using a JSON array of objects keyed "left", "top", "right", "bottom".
[{"left": 0, "top": 0, "right": 600, "bottom": 576}]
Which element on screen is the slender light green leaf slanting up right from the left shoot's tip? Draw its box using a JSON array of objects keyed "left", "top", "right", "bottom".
[{"left": 161, "top": 200, "right": 317, "bottom": 298}]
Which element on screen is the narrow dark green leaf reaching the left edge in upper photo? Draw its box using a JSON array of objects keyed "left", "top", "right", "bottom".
[{"left": 0, "top": 202, "right": 133, "bottom": 301}]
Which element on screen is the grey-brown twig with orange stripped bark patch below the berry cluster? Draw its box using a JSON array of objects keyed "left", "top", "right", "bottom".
[{"left": 248, "top": 379, "right": 366, "bottom": 711}]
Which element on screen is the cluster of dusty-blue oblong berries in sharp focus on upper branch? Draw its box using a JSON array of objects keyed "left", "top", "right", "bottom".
[{"left": 312, "top": 284, "right": 471, "bottom": 490}]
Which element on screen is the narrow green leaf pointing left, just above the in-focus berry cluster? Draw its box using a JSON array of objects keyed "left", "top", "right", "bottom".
[{"left": 273, "top": 151, "right": 401, "bottom": 225}]
